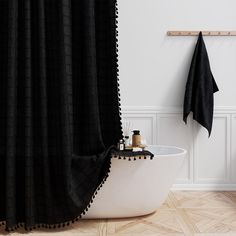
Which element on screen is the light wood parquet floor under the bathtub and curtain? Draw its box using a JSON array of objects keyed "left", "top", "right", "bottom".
[{"left": 0, "top": 191, "right": 236, "bottom": 236}]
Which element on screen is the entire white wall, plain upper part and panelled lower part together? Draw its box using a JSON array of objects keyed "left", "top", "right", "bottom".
[{"left": 118, "top": 0, "right": 236, "bottom": 189}]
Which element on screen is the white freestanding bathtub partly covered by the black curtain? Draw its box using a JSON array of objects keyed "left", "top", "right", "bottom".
[{"left": 83, "top": 145, "right": 186, "bottom": 219}]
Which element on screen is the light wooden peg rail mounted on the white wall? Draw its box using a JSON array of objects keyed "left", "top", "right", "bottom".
[{"left": 167, "top": 31, "right": 236, "bottom": 36}]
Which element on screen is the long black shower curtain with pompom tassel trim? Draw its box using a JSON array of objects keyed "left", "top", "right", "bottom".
[{"left": 0, "top": 0, "right": 122, "bottom": 230}]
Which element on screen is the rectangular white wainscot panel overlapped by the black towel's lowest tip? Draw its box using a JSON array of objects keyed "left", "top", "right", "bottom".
[{"left": 194, "top": 114, "right": 230, "bottom": 184}]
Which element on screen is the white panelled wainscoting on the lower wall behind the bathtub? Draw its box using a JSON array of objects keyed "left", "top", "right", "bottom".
[{"left": 122, "top": 106, "right": 236, "bottom": 190}]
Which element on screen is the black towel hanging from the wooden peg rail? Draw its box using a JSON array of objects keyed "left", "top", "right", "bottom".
[{"left": 183, "top": 32, "right": 219, "bottom": 137}]
